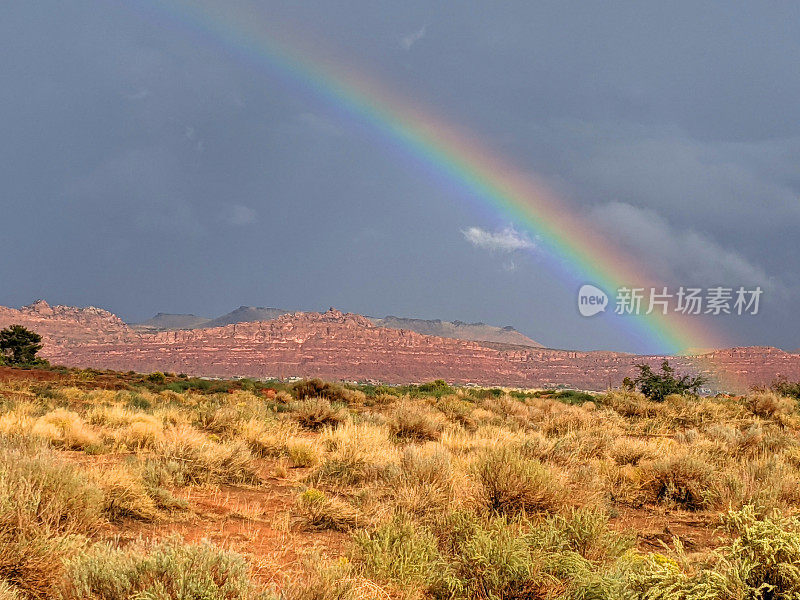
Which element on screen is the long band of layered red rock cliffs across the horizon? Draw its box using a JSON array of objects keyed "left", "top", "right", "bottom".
[{"left": 0, "top": 301, "right": 800, "bottom": 390}]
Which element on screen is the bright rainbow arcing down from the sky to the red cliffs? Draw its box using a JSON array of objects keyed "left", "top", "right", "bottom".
[{"left": 122, "top": 0, "right": 740, "bottom": 384}]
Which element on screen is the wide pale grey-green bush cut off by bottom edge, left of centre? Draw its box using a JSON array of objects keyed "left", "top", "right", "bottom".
[{"left": 61, "top": 538, "right": 266, "bottom": 600}]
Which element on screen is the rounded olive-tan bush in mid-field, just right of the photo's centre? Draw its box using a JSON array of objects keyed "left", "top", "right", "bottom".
[{"left": 476, "top": 447, "right": 564, "bottom": 514}]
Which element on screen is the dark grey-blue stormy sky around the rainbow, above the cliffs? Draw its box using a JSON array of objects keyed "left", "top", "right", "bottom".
[{"left": 0, "top": 0, "right": 800, "bottom": 351}]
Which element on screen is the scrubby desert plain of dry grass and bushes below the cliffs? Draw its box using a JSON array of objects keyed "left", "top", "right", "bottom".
[{"left": 0, "top": 368, "right": 800, "bottom": 600}]
